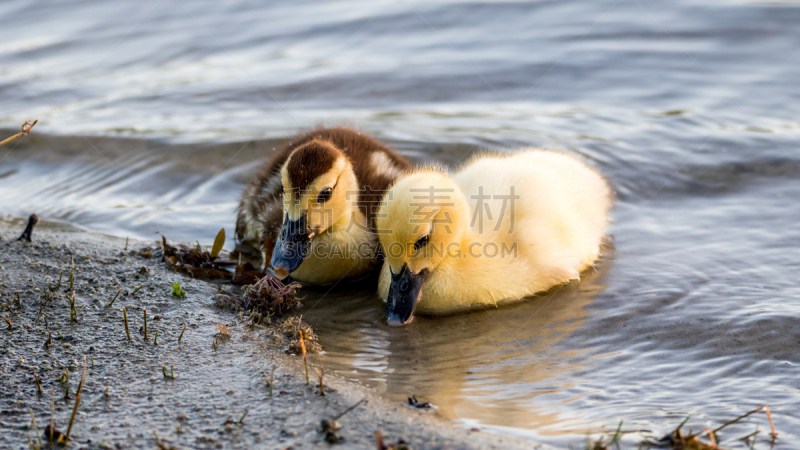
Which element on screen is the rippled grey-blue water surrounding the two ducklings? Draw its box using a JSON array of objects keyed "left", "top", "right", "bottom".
[{"left": 0, "top": 0, "right": 800, "bottom": 448}]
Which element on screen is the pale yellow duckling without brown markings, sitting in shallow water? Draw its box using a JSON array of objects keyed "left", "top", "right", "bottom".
[{"left": 377, "top": 149, "right": 612, "bottom": 325}]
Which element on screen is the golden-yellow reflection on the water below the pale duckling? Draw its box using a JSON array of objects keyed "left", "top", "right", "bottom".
[{"left": 303, "top": 252, "right": 612, "bottom": 432}]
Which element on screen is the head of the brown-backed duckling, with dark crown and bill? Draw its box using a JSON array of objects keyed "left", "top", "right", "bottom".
[{"left": 270, "top": 139, "right": 358, "bottom": 279}]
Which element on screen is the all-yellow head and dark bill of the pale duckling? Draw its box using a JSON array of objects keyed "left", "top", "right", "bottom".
[{"left": 377, "top": 169, "right": 469, "bottom": 325}]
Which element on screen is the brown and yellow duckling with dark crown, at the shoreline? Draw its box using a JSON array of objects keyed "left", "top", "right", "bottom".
[{"left": 236, "top": 128, "right": 411, "bottom": 284}]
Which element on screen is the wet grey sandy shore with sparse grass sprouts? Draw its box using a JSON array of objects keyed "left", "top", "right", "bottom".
[{"left": 0, "top": 218, "right": 533, "bottom": 449}]
